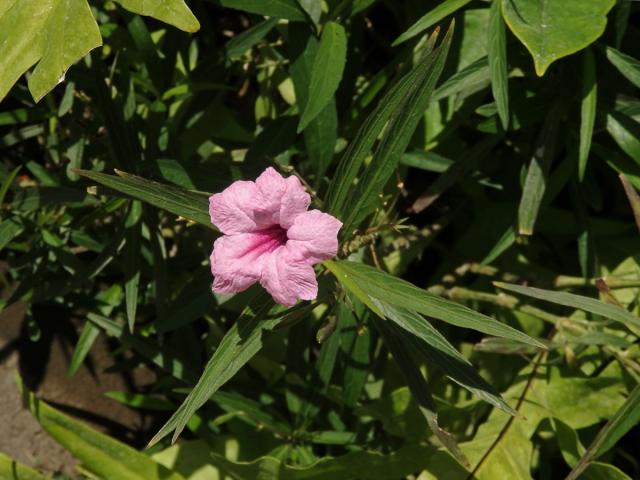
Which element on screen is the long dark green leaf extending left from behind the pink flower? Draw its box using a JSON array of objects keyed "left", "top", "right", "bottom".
[{"left": 75, "top": 170, "right": 214, "bottom": 229}]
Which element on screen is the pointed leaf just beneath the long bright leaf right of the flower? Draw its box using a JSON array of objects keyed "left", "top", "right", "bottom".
[{"left": 377, "top": 301, "right": 521, "bottom": 414}]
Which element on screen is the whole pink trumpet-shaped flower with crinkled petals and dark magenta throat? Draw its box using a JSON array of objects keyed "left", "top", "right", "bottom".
[{"left": 209, "top": 167, "right": 342, "bottom": 306}]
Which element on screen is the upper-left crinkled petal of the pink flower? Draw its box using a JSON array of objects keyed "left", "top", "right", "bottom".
[{"left": 209, "top": 181, "right": 264, "bottom": 235}]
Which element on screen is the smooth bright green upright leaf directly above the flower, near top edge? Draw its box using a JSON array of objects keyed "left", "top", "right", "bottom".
[{"left": 298, "top": 22, "right": 347, "bottom": 132}]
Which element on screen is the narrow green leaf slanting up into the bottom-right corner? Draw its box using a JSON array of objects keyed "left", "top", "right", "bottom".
[{"left": 567, "top": 385, "right": 640, "bottom": 480}]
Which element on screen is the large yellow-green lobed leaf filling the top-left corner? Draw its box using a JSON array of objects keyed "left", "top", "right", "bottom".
[{"left": 0, "top": 0, "right": 102, "bottom": 101}]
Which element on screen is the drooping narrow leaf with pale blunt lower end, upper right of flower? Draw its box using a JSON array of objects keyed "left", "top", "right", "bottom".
[{"left": 518, "top": 106, "right": 561, "bottom": 235}]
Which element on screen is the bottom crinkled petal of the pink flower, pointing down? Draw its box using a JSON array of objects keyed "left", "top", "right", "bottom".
[{"left": 260, "top": 247, "right": 318, "bottom": 307}]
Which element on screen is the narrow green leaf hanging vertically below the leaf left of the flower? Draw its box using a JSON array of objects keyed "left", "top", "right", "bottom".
[{"left": 124, "top": 200, "right": 142, "bottom": 333}]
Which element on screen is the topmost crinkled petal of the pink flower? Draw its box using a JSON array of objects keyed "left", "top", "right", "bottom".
[{"left": 256, "top": 167, "right": 311, "bottom": 228}]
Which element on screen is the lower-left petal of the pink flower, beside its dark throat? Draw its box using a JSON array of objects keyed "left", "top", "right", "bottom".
[{"left": 210, "top": 233, "right": 270, "bottom": 293}]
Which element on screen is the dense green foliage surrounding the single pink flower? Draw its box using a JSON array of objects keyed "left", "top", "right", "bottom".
[{"left": 0, "top": 0, "right": 640, "bottom": 480}]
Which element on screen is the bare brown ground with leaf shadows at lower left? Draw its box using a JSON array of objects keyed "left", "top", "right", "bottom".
[{"left": 0, "top": 304, "right": 154, "bottom": 476}]
